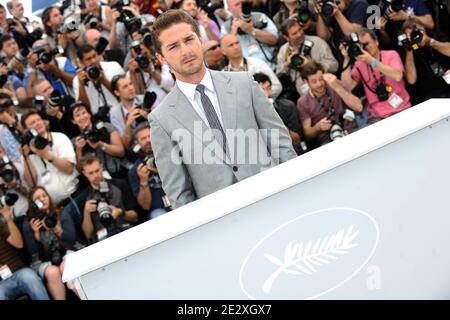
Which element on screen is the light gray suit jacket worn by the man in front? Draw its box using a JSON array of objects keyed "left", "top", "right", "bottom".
[{"left": 149, "top": 70, "right": 296, "bottom": 208}]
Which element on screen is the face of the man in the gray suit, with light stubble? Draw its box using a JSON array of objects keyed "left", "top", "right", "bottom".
[{"left": 157, "top": 23, "right": 205, "bottom": 80}]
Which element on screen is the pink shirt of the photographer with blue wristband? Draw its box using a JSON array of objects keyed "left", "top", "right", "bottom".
[{"left": 352, "top": 50, "right": 411, "bottom": 118}]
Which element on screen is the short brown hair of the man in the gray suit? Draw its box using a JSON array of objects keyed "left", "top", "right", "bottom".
[{"left": 152, "top": 9, "right": 200, "bottom": 54}]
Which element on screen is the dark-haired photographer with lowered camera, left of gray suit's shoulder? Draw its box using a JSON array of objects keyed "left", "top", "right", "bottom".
[{"left": 111, "top": 75, "right": 151, "bottom": 149}]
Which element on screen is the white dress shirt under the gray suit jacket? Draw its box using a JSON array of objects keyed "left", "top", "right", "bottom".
[{"left": 177, "top": 69, "right": 225, "bottom": 130}]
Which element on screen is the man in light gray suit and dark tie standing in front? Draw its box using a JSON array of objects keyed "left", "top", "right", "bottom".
[{"left": 149, "top": 10, "right": 296, "bottom": 208}]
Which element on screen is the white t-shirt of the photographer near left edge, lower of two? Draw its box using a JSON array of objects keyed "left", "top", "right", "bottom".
[{"left": 30, "top": 132, "right": 78, "bottom": 204}]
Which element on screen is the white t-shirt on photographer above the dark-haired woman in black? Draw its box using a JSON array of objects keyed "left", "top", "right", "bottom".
[{"left": 73, "top": 61, "right": 125, "bottom": 114}]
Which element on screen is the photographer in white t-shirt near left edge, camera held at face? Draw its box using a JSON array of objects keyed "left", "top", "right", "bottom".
[{"left": 20, "top": 111, "right": 78, "bottom": 204}]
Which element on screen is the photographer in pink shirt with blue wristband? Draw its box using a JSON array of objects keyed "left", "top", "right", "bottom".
[{"left": 341, "top": 28, "right": 411, "bottom": 124}]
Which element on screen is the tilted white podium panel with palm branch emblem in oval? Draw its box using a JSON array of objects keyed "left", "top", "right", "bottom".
[{"left": 63, "top": 99, "right": 450, "bottom": 299}]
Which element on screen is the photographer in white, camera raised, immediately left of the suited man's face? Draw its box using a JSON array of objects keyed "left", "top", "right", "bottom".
[{"left": 127, "top": 37, "right": 175, "bottom": 103}]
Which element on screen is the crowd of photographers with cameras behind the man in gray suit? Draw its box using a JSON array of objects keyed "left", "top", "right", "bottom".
[{"left": 0, "top": 0, "right": 450, "bottom": 300}]
